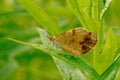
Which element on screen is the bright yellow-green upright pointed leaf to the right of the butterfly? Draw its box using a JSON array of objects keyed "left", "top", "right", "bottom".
[{"left": 95, "top": 28, "right": 117, "bottom": 74}]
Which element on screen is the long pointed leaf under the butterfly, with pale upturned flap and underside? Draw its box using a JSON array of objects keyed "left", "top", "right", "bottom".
[{"left": 10, "top": 28, "right": 99, "bottom": 80}]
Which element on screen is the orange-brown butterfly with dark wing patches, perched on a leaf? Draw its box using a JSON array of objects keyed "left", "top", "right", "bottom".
[{"left": 51, "top": 27, "right": 97, "bottom": 56}]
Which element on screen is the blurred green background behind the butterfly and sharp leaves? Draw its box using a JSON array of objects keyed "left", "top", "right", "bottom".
[{"left": 0, "top": 0, "right": 120, "bottom": 80}]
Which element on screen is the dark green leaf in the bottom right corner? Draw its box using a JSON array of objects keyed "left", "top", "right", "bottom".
[{"left": 101, "top": 56, "right": 120, "bottom": 80}]
